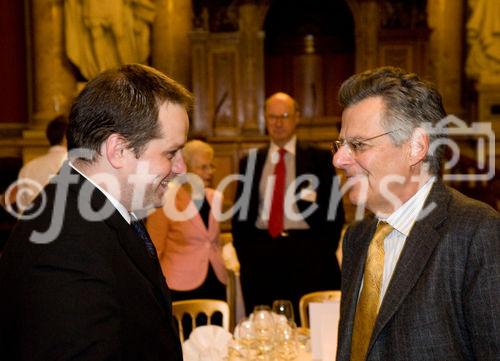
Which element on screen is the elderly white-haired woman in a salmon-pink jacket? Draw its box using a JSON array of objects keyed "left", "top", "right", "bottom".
[{"left": 147, "top": 140, "right": 227, "bottom": 301}]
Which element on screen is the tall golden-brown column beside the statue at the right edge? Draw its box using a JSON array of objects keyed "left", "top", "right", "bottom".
[{"left": 427, "top": 0, "right": 464, "bottom": 117}]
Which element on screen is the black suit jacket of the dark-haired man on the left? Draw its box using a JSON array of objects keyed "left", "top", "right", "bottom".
[{"left": 0, "top": 165, "right": 182, "bottom": 361}]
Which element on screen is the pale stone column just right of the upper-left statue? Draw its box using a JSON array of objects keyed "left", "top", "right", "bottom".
[{"left": 151, "top": 0, "right": 193, "bottom": 87}]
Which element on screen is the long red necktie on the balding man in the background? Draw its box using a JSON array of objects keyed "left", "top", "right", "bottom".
[{"left": 269, "top": 148, "right": 286, "bottom": 238}]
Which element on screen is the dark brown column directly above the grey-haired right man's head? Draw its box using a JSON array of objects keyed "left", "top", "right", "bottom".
[{"left": 347, "top": 0, "right": 380, "bottom": 73}]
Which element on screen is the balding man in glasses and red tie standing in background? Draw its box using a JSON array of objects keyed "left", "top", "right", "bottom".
[{"left": 232, "top": 93, "right": 344, "bottom": 316}]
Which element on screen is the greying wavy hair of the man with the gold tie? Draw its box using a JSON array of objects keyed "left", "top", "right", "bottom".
[{"left": 339, "top": 67, "right": 446, "bottom": 175}]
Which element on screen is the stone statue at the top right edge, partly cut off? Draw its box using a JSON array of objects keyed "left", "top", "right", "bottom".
[{"left": 466, "top": 0, "right": 500, "bottom": 83}]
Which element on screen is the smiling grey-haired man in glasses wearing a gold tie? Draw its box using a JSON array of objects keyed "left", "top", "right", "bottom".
[{"left": 333, "top": 67, "right": 500, "bottom": 361}]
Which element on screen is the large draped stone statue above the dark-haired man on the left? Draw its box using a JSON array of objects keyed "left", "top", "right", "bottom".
[{"left": 64, "top": 0, "right": 155, "bottom": 79}]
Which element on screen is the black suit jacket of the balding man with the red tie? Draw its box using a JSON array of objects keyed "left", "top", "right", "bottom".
[{"left": 232, "top": 141, "right": 344, "bottom": 317}]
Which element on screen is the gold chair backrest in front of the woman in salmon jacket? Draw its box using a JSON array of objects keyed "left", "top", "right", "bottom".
[{"left": 172, "top": 299, "right": 229, "bottom": 342}]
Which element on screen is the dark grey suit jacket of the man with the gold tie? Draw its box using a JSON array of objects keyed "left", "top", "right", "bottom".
[{"left": 337, "top": 181, "right": 500, "bottom": 361}]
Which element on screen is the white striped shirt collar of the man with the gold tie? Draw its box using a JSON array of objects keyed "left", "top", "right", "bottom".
[{"left": 380, "top": 177, "right": 436, "bottom": 237}]
